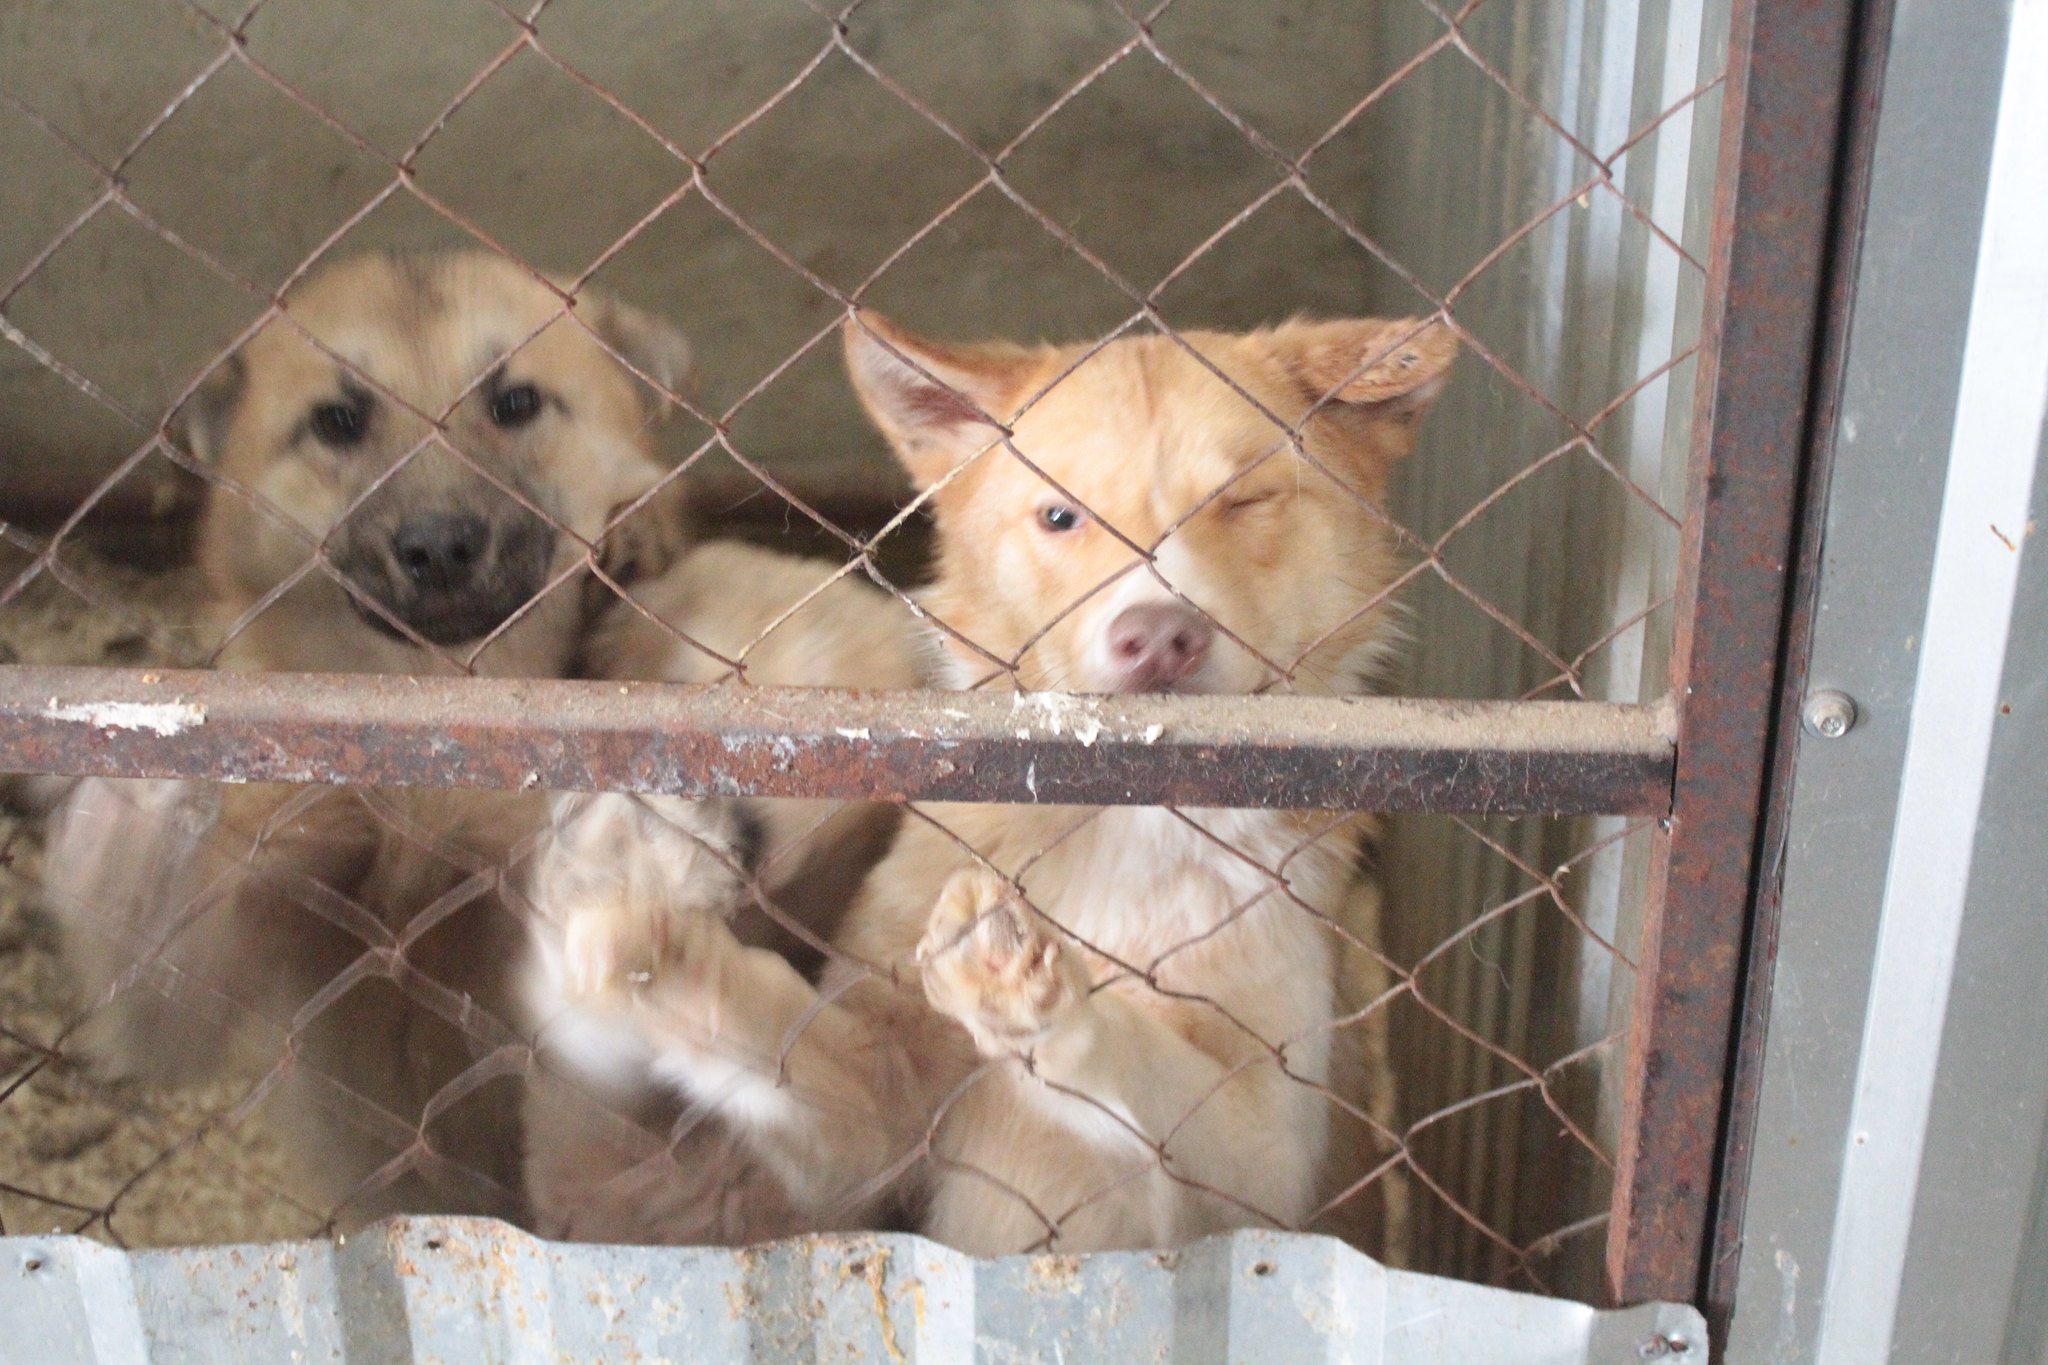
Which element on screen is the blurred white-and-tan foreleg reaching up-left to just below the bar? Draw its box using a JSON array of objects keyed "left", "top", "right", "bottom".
[{"left": 532, "top": 796, "right": 924, "bottom": 1226}]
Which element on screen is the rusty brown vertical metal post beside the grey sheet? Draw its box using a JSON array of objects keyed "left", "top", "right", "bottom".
[{"left": 1608, "top": 0, "right": 1858, "bottom": 1302}]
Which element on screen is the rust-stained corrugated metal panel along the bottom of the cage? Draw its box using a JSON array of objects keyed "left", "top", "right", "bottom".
[{"left": 0, "top": 1218, "right": 1706, "bottom": 1365}]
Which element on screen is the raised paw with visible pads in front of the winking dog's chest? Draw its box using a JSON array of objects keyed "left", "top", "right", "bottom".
[{"left": 918, "top": 868, "right": 1087, "bottom": 1056}]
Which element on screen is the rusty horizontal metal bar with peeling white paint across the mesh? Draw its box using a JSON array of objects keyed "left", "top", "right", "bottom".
[{"left": 0, "top": 665, "right": 1673, "bottom": 814}]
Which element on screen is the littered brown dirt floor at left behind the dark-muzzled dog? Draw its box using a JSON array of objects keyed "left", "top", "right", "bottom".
[{"left": 0, "top": 559, "right": 319, "bottom": 1246}]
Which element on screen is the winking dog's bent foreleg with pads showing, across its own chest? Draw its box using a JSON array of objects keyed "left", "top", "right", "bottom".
[{"left": 918, "top": 868, "right": 1323, "bottom": 1236}]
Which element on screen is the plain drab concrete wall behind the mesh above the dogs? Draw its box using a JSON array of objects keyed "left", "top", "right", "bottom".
[{"left": 0, "top": 0, "right": 1374, "bottom": 515}]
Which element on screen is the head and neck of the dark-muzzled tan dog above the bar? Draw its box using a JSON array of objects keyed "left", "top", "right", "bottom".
[{"left": 184, "top": 254, "right": 690, "bottom": 677}]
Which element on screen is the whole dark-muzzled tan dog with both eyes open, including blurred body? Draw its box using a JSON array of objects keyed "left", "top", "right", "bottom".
[{"left": 47, "top": 254, "right": 688, "bottom": 1222}]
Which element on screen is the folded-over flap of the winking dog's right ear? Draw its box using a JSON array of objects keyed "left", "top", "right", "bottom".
[{"left": 1274, "top": 317, "right": 1458, "bottom": 426}]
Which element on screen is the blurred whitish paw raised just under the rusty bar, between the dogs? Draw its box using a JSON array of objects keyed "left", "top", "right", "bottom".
[{"left": 532, "top": 794, "right": 745, "bottom": 1001}]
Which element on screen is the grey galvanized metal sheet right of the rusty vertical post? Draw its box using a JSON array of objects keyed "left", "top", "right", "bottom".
[{"left": 1714, "top": 0, "right": 2048, "bottom": 1365}]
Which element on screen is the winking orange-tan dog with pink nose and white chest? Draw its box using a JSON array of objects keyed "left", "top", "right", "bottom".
[{"left": 541, "top": 319, "right": 1456, "bottom": 1254}]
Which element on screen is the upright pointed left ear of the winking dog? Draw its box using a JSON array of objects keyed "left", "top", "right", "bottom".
[{"left": 842, "top": 313, "right": 1038, "bottom": 487}]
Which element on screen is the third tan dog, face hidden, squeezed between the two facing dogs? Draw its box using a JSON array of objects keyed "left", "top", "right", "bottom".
[{"left": 526, "top": 542, "right": 920, "bottom": 1244}]
